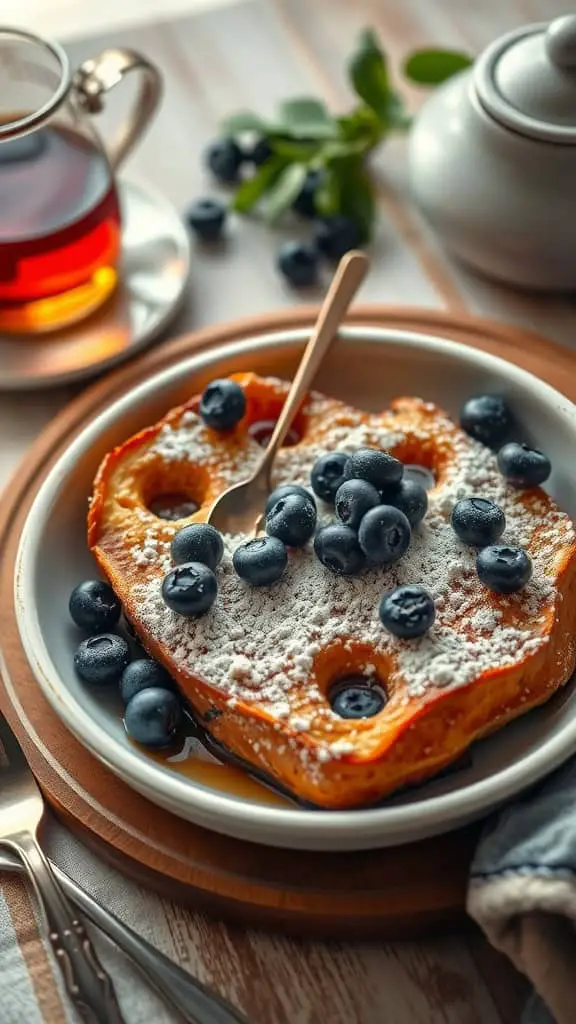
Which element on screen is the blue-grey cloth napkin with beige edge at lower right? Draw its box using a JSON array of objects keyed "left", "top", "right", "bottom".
[{"left": 467, "top": 759, "right": 576, "bottom": 1024}]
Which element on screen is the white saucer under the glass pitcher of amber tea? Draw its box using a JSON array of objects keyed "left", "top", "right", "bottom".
[{"left": 0, "top": 181, "right": 190, "bottom": 391}]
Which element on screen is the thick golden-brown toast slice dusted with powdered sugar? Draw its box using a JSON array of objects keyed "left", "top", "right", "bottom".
[{"left": 88, "top": 374, "right": 576, "bottom": 808}]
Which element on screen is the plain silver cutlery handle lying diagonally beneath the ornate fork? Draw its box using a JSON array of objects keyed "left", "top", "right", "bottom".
[{"left": 47, "top": 865, "right": 249, "bottom": 1024}]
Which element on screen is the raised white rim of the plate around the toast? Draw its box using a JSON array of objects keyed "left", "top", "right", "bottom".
[{"left": 14, "top": 325, "right": 576, "bottom": 850}]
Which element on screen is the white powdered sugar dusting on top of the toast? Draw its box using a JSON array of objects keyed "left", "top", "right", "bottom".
[{"left": 114, "top": 380, "right": 574, "bottom": 763}]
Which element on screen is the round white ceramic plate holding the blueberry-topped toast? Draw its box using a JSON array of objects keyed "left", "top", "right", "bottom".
[{"left": 15, "top": 328, "right": 576, "bottom": 850}]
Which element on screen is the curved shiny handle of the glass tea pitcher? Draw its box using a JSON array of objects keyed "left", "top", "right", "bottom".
[{"left": 72, "top": 49, "right": 162, "bottom": 170}]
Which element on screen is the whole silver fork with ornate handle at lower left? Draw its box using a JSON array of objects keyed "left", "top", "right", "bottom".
[{"left": 0, "top": 723, "right": 125, "bottom": 1024}]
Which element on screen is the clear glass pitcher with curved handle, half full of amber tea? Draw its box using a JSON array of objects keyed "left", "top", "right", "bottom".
[{"left": 0, "top": 29, "right": 160, "bottom": 334}]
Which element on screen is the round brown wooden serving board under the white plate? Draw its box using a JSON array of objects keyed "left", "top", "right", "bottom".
[{"left": 0, "top": 306, "right": 576, "bottom": 938}]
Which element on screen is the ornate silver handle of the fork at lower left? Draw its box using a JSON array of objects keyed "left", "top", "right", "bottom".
[{"left": 8, "top": 833, "right": 125, "bottom": 1024}]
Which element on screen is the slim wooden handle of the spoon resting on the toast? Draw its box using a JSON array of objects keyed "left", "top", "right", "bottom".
[{"left": 257, "top": 250, "right": 368, "bottom": 476}]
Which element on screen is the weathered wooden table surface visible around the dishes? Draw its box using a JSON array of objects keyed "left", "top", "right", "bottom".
[{"left": 0, "top": 0, "right": 576, "bottom": 1024}]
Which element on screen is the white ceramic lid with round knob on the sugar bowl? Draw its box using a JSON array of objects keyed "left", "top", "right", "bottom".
[{"left": 474, "top": 14, "right": 576, "bottom": 144}]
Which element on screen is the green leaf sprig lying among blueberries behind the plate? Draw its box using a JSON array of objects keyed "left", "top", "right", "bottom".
[{"left": 217, "top": 29, "right": 471, "bottom": 242}]
